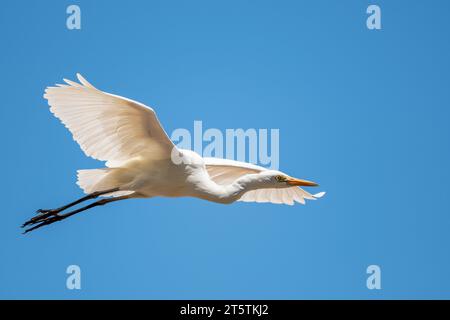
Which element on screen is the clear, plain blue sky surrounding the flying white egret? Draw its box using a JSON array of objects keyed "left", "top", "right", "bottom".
[{"left": 0, "top": 0, "right": 450, "bottom": 299}]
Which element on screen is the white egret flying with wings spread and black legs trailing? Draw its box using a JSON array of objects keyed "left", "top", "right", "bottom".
[{"left": 22, "top": 74, "right": 325, "bottom": 233}]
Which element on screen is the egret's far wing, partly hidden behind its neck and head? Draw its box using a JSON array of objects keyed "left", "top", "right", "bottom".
[{"left": 204, "top": 158, "right": 324, "bottom": 205}]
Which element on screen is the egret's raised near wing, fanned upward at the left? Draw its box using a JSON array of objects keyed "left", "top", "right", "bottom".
[{"left": 44, "top": 74, "right": 175, "bottom": 167}]
